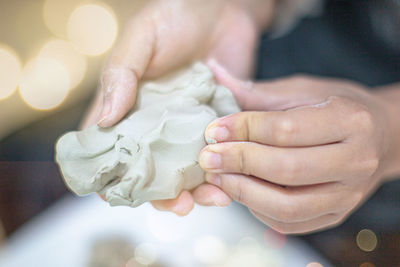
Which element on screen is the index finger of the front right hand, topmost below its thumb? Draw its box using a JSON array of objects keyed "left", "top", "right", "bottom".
[{"left": 205, "top": 97, "right": 350, "bottom": 147}]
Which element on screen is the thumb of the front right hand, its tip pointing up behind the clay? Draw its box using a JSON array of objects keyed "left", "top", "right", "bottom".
[{"left": 207, "top": 59, "right": 326, "bottom": 111}]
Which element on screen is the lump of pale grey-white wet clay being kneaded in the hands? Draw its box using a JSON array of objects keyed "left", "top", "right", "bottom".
[{"left": 56, "top": 63, "right": 240, "bottom": 207}]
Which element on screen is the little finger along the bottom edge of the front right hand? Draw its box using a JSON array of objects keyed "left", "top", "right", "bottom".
[{"left": 250, "top": 210, "right": 342, "bottom": 234}]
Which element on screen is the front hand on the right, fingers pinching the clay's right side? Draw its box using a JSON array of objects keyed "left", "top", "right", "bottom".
[{"left": 194, "top": 61, "right": 398, "bottom": 234}]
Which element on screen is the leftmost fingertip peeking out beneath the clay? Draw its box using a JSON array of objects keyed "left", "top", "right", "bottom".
[{"left": 151, "top": 191, "right": 194, "bottom": 216}]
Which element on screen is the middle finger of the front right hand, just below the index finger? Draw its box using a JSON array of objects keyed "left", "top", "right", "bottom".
[{"left": 199, "top": 142, "right": 352, "bottom": 186}]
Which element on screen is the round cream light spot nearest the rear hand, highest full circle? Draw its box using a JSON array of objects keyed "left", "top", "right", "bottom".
[{"left": 67, "top": 4, "right": 118, "bottom": 56}]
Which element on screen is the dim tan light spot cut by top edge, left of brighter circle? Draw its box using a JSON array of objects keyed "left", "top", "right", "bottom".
[{"left": 42, "top": 0, "right": 83, "bottom": 37}]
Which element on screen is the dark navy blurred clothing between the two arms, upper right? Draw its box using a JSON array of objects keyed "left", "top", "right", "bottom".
[{"left": 257, "top": 1, "right": 400, "bottom": 86}]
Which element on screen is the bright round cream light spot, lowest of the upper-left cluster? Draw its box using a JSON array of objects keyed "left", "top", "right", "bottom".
[{"left": 20, "top": 58, "right": 70, "bottom": 110}]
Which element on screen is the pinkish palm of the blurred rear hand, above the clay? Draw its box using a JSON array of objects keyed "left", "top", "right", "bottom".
[{"left": 145, "top": 0, "right": 257, "bottom": 78}]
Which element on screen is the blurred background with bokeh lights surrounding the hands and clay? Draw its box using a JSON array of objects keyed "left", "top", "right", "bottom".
[{"left": 0, "top": 0, "right": 400, "bottom": 267}]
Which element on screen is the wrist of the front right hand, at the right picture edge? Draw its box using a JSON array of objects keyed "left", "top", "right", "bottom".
[{"left": 376, "top": 84, "right": 400, "bottom": 181}]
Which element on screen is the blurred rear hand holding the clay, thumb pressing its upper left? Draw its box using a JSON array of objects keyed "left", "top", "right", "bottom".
[{"left": 82, "top": 0, "right": 273, "bottom": 214}]
